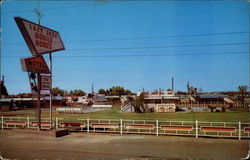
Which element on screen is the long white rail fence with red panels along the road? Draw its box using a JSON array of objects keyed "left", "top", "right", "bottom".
[{"left": 1, "top": 116, "right": 250, "bottom": 140}]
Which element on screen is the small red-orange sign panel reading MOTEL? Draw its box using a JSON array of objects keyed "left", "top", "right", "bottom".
[{"left": 20, "top": 56, "right": 50, "bottom": 74}]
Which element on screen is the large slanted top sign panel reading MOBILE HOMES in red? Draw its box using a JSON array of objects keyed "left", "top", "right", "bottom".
[{"left": 14, "top": 17, "right": 65, "bottom": 56}]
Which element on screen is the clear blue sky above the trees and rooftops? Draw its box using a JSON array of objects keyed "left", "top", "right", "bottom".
[{"left": 1, "top": 0, "right": 250, "bottom": 94}]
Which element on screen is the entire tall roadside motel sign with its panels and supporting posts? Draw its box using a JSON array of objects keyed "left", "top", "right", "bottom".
[{"left": 14, "top": 16, "right": 65, "bottom": 130}]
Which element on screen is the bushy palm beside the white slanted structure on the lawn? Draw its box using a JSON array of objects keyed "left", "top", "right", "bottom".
[{"left": 125, "top": 93, "right": 149, "bottom": 113}]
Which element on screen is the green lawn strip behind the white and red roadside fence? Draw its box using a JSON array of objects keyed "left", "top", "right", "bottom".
[{"left": 16, "top": 107, "right": 249, "bottom": 122}]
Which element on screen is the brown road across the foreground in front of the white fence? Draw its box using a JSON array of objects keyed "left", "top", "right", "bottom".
[{"left": 0, "top": 130, "right": 249, "bottom": 160}]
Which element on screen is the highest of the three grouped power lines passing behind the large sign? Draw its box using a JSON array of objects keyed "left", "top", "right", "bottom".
[{"left": 4, "top": 32, "right": 249, "bottom": 45}]
